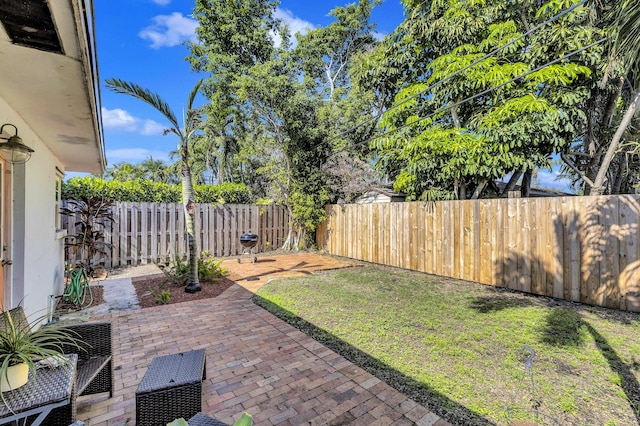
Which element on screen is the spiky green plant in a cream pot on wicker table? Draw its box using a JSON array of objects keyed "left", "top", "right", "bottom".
[{"left": 0, "top": 308, "right": 79, "bottom": 394}]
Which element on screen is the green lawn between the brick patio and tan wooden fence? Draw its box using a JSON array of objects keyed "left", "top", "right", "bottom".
[{"left": 254, "top": 266, "right": 640, "bottom": 425}]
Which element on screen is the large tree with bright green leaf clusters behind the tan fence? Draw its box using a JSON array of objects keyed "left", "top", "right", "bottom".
[{"left": 365, "top": 0, "right": 602, "bottom": 199}]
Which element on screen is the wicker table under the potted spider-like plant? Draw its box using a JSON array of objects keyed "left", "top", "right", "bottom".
[{"left": 0, "top": 354, "right": 78, "bottom": 426}]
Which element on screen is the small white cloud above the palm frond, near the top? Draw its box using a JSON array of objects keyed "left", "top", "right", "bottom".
[{"left": 138, "top": 12, "right": 198, "bottom": 49}]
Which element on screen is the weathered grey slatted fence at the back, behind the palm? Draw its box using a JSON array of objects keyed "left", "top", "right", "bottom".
[{"left": 63, "top": 202, "right": 289, "bottom": 268}]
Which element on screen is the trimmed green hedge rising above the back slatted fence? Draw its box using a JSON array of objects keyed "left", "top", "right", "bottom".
[{"left": 62, "top": 176, "right": 251, "bottom": 204}]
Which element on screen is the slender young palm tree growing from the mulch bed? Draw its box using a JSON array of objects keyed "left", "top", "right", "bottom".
[{"left": 106, "top": 78, "right": 202, "bottom": 293}]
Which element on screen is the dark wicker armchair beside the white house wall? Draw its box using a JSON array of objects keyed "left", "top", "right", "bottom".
[{"left": 3, "top": 306, "right": 113, "bottom": 424}]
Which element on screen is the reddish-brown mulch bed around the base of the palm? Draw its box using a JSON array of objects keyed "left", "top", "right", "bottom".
[{"left": 133, "top": 276, "right": 234, "bottom": 309}]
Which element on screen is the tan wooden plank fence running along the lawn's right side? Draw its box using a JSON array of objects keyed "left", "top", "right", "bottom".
[{"left": 317, "top": 195, "right": 640, "bottom": 312}]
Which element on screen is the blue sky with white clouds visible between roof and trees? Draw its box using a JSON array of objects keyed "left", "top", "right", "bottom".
[{"left": 94, "top": 0, "right": 566, "bottom": 189}]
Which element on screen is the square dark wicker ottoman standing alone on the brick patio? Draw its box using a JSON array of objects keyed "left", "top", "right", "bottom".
[{"left": 136, "top": 349, "right": 206, "bottom": 426}]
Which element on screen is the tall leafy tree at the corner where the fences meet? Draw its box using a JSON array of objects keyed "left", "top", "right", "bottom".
[{"left": 190, "top": 0, "right": 377, "bottom": 249}]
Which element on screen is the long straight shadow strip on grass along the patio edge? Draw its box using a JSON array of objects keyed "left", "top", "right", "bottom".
[{"left": 252, "top": 294, "right": 494, "bottom": 426}]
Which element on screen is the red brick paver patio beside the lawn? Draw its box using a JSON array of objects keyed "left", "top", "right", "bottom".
[{"left": 78, "top": 258, "right": 448, "bottom": 426}]
